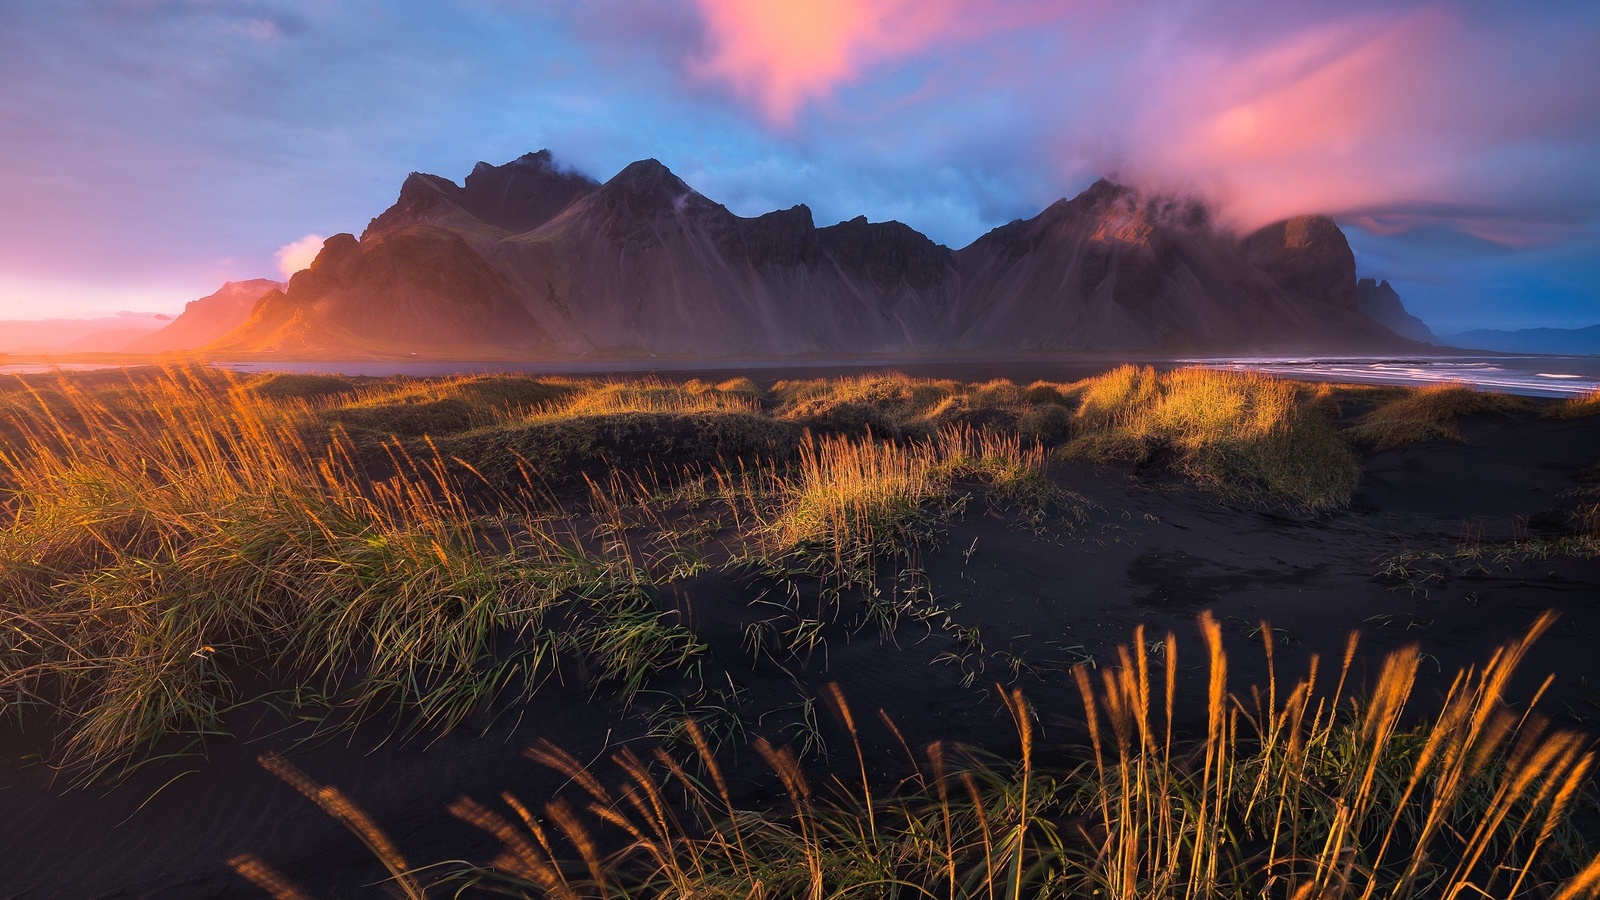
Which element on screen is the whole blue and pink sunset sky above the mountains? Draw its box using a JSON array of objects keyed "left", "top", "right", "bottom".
[{"left": 0, "top": 0, "right": 1600, "bottom": 333}]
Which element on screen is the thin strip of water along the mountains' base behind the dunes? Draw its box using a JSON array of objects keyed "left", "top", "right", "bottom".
[{"left": 0, "top": 356, "right": 1600, "bottom": 397}]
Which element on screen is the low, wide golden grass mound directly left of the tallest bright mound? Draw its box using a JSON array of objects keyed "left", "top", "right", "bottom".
[{"left": 773, "top": 372, "right": 1072, "bottom": 442}]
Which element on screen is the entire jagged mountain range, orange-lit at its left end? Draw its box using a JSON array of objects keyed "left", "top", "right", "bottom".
[{"left": 211, "top": 151, "right": 1414, "bottom": 357}]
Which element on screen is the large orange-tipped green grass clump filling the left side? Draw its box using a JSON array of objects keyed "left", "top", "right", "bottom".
[{"left": 0, "top": 372, "right": 693, "bottom": 767}]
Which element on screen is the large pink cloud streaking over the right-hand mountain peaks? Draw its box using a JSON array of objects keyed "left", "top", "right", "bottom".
[{"left": 1128, "top": 10, "right": 1470, "bottom": 227}]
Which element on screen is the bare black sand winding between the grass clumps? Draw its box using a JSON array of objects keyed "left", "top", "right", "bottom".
[{"left": 0, "top": 384, "right": 1600, "bottom": 898}]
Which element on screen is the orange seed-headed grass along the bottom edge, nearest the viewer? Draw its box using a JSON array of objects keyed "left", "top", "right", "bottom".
[{"left": 232, "top": 613, "right": 1600, "bottom": 900}]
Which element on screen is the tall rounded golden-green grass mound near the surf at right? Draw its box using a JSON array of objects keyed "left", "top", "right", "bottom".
[{"left": 1064, "top": 365, "right": 1360, "bottom": 511}]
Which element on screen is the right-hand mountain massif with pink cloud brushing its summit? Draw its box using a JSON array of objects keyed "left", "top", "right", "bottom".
[{"left": 955, "top": 181, "right": 1395, "bottom": 352}]
